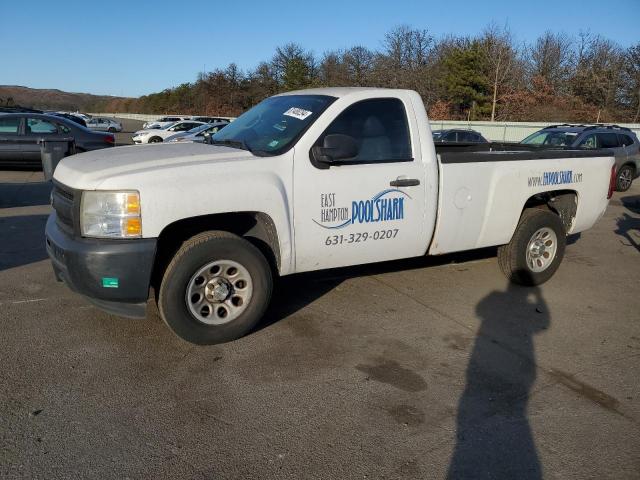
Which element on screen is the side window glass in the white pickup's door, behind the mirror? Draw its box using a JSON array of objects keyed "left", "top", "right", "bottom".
[{"left": 318, "top": 98, "right": 412, "bottom": 163}]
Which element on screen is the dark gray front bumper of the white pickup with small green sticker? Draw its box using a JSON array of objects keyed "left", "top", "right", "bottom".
[{"left": 45, "top": 213, "right": 156, "bottom": 318}]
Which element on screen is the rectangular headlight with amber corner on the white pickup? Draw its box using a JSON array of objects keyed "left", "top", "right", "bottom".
[{"left": 80, "top": 190, "right": 142, "bottom": 238}]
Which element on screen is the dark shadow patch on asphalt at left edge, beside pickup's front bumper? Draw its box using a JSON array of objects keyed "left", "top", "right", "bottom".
[{"left": 0, "top": 215, "right": 48, "bottom": 271}]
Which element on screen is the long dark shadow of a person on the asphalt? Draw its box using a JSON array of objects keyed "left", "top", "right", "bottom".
[{"left": 447, "top": 283, "right": 551, "bottom": 480}]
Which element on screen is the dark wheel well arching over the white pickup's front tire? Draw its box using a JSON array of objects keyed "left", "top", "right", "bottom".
[{"left": 152, "top": 212, "right": 280, "bottom": 288}]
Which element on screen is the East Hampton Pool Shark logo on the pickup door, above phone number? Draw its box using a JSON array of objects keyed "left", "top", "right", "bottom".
[{"left": 313, "top": 188, "right": 411, "bottom": 230}]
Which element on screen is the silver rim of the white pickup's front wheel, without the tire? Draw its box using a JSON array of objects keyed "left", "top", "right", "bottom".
[{"left": 185, "top": 260, "right": 253, "bottom": 325}]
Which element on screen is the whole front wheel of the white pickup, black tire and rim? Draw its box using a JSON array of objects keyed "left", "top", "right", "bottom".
[{"left": 158, "top": 231, "right": 273, "bottom": 345}]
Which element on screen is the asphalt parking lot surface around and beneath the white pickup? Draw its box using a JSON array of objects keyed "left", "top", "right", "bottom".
[{"left": 0, "top": 152, "right": 640, "bottom": 479}]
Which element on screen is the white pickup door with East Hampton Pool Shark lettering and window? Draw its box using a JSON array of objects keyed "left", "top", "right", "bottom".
[{"left": 294, "top": 98, "right": 428, "bottom": 272}]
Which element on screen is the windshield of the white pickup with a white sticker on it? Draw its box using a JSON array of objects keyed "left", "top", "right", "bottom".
[{"left": 211, "top": 95, "right": 335, "bottom": 155}]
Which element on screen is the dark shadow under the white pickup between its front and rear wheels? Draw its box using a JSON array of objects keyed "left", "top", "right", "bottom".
[{"left": 254, "top": 248, "right": 496, "bottom": 331}]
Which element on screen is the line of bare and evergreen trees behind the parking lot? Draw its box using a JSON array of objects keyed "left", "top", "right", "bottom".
[{"left": 104, "top": 25, "right": 640, "bottom": 122}]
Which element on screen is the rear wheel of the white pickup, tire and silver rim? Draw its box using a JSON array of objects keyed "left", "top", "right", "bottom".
[{"left": 498, "top": 209, "right": 567, "bottom": 285}]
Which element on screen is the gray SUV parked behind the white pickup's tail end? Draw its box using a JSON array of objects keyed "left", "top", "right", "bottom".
[{"left": 521, "top": 124, "right": 640, "bottom": 192}]
